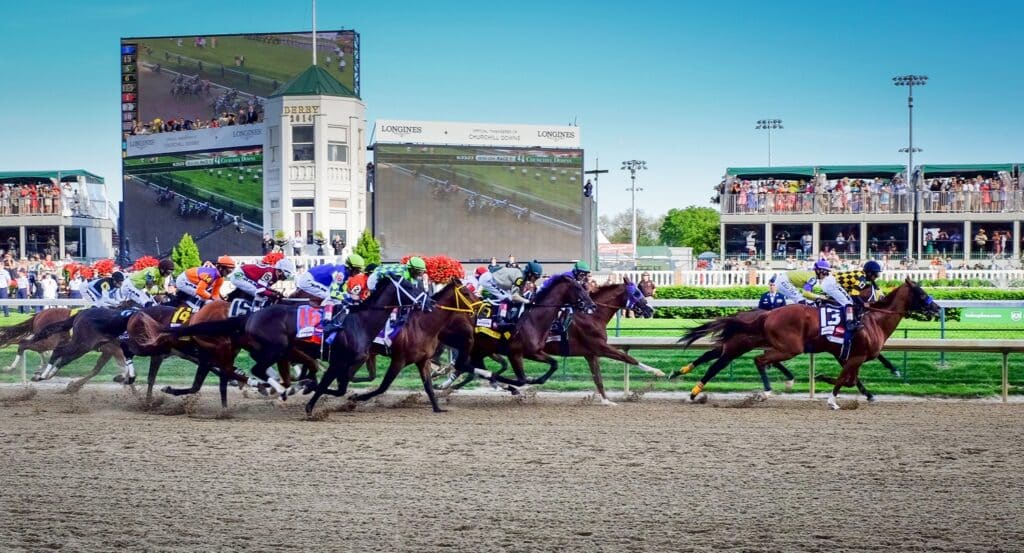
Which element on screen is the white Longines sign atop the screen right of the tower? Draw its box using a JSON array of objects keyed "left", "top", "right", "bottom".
[{"left": 375, "top": 119, "right": 581, "bottom": 147}]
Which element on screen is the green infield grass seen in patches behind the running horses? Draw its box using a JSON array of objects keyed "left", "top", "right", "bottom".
[{"left": 0, "top": 313, "right": 1024, "bottom": 397}]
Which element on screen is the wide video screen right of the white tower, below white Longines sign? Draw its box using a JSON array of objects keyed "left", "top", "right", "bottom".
[{"left": 373, "top": 144, "right": 584, "bottom": 262}]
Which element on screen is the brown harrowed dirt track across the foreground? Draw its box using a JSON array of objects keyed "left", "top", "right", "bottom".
[{"left": 0, "top": 388, "right": 1024, "bottom": 553}]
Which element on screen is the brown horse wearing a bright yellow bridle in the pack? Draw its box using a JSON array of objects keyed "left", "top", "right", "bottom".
[{"left": 349, "top": 279, "right": 481, "bottom": 413}]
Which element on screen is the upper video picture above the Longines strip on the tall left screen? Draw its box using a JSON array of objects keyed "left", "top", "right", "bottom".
[{"left": 121, "top": 31, "right": 359, "bottom": 132}]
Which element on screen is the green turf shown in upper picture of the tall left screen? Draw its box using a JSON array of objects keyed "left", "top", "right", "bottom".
[{"left": 138, "top": 37, "right": 354, "bottom": 96}]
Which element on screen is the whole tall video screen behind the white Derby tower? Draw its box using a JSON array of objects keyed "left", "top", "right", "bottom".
[{"left": 120, "top": 31, "right": 359, "bottom": 257}]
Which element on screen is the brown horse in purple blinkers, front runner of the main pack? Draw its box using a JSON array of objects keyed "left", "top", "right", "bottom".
[{"left": 479, "top": 277, "right": 665, "bottom": 406}]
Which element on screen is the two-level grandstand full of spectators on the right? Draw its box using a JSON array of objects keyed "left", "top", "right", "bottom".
[{"left": 716, "top": 164, "right": 1024, "bottom": 268}]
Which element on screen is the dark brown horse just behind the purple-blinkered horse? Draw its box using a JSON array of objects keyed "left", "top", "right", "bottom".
[{"left": 454, "top": 274, "right": 597, "bottom": 387}]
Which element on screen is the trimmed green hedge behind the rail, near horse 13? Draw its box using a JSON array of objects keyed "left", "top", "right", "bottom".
[{"left": 654, "top": 286, "right": 1024, "bottom": 321}]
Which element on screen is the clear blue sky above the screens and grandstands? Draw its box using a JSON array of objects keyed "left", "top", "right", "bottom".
[{"left": 0, "top": 0, "right": 1024, "bottom": 217}]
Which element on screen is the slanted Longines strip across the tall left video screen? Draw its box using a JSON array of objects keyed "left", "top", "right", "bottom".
[{"left": 126, "top": 125, "right": 266, "bottom": 158}]
